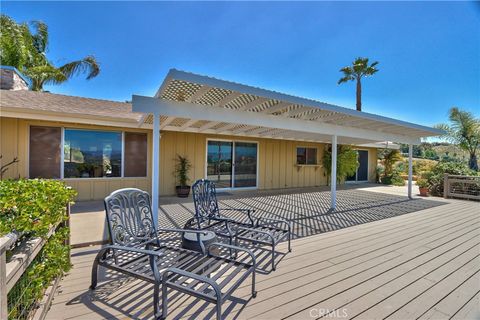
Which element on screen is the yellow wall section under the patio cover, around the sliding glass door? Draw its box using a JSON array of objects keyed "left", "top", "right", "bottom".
[{"left": 160, "top": 131, "right": 327, "bottom": 194}]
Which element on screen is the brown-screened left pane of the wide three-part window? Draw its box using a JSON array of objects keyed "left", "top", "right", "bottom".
[{"left": 29, "top": 126, "right": 62, "bottom": 179}]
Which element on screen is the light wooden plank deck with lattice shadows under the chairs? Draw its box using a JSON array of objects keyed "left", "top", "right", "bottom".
[{"left": 47, "top": 190, "right": 480, "bottom": 319}]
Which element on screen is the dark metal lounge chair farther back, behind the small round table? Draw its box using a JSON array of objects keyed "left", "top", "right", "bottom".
[{"left": 186, "top": 179, "right": 292, "bottom": 270}]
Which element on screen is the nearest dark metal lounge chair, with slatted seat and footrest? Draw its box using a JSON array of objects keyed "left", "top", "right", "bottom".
[{"left": 90, "top": 188, "right": 256, "bottom": 319}]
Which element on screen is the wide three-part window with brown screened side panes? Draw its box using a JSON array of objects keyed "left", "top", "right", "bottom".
[{"left": 29, "top": 126, "right": 148, "bottom": 179}]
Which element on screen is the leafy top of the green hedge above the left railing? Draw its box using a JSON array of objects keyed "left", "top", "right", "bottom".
[{"left": 0, "top": 179, "right": 76, "bottom": 238}]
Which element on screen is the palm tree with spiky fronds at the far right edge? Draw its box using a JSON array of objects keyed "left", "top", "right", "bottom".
[{"left": 436, "top": 107, "right": 480, "bottom": 171}]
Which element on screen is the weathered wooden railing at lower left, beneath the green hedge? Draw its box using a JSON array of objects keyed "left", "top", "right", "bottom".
[{"left": 0, "top": 205, "right": 70, "bottom": 320}]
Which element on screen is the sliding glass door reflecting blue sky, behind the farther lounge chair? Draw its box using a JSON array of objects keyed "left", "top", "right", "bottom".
[{"left": 207, "top": 140, "right": 258, "bottom": 188}]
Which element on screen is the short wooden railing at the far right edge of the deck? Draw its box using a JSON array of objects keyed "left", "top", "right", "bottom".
[{"left": 443, "top": 174, "right": 480, "bottom": 201}]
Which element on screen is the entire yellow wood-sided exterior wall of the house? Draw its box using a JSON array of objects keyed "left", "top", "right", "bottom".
[{"left": 0, "top": 117, "right": 377, "bottom": 200}]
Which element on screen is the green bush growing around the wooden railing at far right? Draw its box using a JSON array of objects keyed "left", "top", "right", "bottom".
[{"left": 427, "top": 161, "right": 477, "bottom": 196}]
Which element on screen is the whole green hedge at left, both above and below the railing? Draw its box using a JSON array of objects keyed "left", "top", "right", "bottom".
[{"left": 0, "top": 179, "right": 76, "bottom": 319}]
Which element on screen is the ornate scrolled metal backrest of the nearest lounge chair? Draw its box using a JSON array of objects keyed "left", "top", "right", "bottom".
[{"left": 104, "top": 188, "right": 158, "bottom": 247}]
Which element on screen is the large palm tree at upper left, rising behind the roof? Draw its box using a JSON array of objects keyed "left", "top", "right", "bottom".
[{"left": 0, "top": 15, "right": 100, "bottom": 91}]
